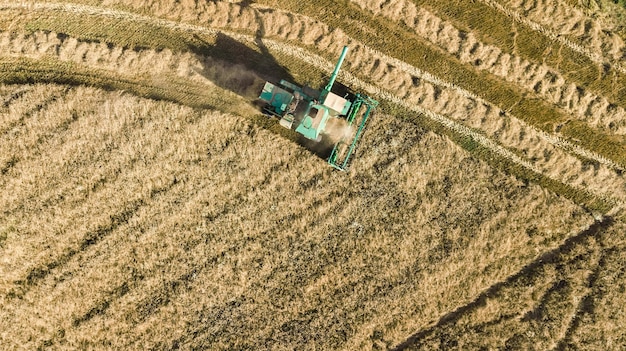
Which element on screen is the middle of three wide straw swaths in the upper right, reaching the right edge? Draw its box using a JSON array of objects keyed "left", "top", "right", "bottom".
[{"left": 354, "top": 0, "right": 626, "bottom": 135}]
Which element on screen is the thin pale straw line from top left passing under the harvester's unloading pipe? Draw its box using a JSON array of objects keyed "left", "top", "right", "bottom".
[{"left": 4, "top": 4, "right": 623, "bottom": 214}]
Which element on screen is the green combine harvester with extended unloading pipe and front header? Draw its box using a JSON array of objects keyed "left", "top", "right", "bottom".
[{"left": 259, "top": 46, "right": 378, "bottom": 171}]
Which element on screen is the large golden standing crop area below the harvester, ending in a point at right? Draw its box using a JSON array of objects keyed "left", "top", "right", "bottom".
[{"left": 0, "top": 82, "right": 593, "bottom": 350}]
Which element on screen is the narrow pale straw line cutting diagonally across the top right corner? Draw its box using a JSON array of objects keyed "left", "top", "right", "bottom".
[{"left": 480, "top": 0, "right": 626, "bottom": 73}]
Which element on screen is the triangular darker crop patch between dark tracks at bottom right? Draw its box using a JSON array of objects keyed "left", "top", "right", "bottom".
[{"left": 394, "top": 217, "right": 615, "bottom": 351}]
